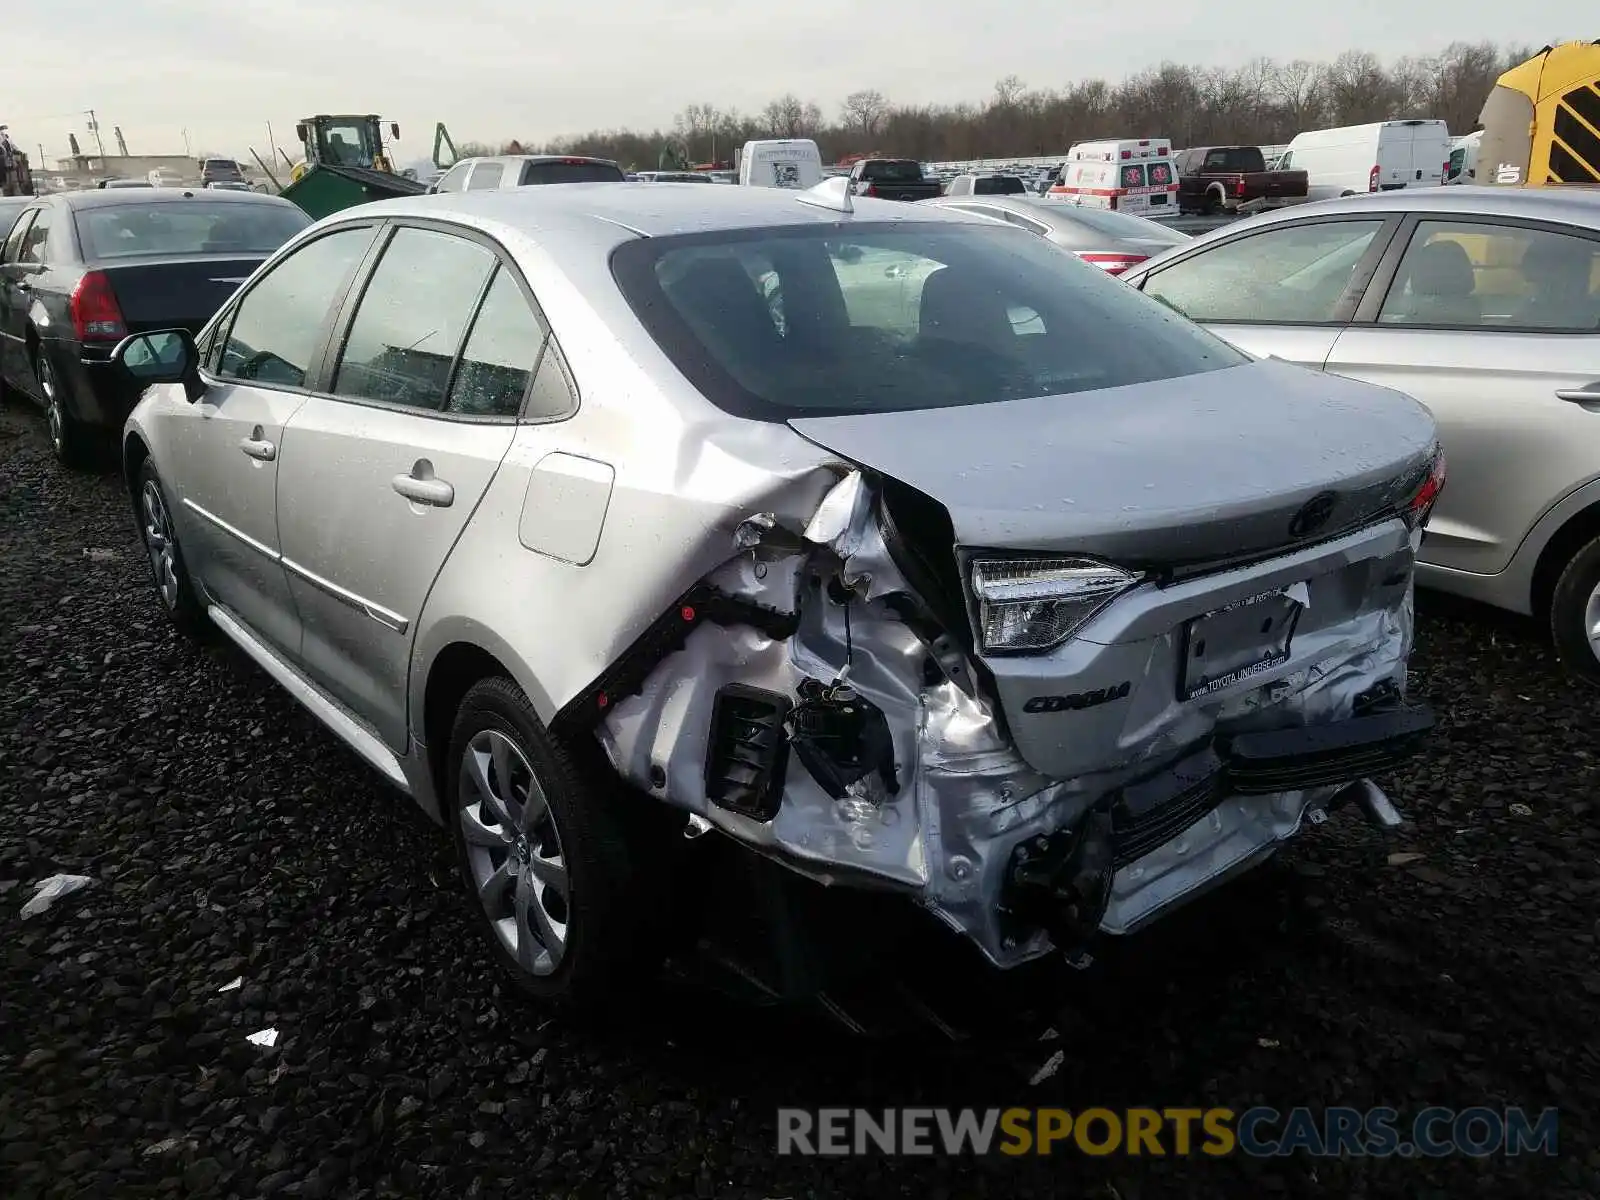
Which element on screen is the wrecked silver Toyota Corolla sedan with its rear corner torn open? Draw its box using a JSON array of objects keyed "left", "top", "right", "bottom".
[{"left": 117, "top": 184, "right": 1443, "bottom": 997}]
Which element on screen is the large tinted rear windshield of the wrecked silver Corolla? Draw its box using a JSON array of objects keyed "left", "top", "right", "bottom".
[{"left": 611, "top": 221, "right": 1248, "bottom": 421}]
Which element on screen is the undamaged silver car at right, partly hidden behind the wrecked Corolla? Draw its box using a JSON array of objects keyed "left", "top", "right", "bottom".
[{"left": 1126, "top": 187, "right": 1600, "bottom": 682}]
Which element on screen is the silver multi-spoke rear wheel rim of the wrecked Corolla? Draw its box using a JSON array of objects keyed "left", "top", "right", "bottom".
[{"left": 459, "top": 730, "right": 571, "bottom": 976}]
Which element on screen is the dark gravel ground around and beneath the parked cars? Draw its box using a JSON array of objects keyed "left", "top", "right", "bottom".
[{"left": 0, "top": 410, "right": 1600, "bottom": 1200}]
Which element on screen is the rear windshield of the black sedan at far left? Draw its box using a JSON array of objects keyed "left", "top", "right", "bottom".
[{"left": 74, "top": 200, "right": 310, "bottom": 259}]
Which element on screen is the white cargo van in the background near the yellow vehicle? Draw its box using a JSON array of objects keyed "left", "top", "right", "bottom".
[{"left": 1278, "top": 120, "right": 1450, "bottom": 200}]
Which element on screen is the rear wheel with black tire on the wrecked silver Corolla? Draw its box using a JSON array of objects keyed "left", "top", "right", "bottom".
[{"left": 443, "top": 677, "right": 661, "bottom": 1008}]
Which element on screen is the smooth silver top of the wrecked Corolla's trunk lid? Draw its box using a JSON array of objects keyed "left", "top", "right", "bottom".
[{"left": 789, "top": 358, "right": 1435, "bottom": 570}]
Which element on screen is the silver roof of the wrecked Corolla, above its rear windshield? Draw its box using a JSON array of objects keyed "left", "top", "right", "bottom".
[{"left": 339, "top": 182, "right": 973, "bottom": 253}]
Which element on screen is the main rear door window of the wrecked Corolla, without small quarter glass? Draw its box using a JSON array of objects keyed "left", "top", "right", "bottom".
[{"left": 331, "top": 227, "right": 496, "bottom": 411}]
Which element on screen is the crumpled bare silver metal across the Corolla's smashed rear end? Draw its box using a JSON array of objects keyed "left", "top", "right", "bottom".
[{"left": 602, "top": 477, "right": 1416, "bottom": 966}]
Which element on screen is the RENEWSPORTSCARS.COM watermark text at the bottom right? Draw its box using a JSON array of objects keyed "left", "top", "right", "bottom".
[{"left": 778, "top": 1107, "right": 1557, "bottom": 1158}]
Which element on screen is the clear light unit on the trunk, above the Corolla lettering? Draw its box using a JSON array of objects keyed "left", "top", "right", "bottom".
[{"left": 973, "top": 558, "right": 1139, "bottom": 653}]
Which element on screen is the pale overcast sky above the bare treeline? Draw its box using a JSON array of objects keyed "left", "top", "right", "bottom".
[{"left": 0, "top": 0, "right": 1600, "bottom": 162}]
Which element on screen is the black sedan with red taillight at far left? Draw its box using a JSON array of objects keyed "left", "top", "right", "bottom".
[{"left": 0, "top": 187, "right": 310, "bottom": 464}]
